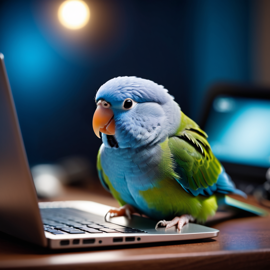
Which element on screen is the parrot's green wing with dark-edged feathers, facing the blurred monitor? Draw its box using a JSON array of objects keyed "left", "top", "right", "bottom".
[{"left": 169, "top": 112, "right": 222, "bottom": 190}]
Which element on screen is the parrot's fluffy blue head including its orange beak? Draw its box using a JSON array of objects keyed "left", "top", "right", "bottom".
[{"left": 93, "top": 77, "right": 180, "bottom": 148}]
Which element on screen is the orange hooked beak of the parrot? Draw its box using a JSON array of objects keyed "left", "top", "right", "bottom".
[{"left": 92, "top": 105, "right": 115, "bottom": 138}]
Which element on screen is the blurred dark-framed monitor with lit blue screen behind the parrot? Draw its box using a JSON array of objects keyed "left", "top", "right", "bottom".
[{"left": 202, "top": 85, "right": 270, "bottom": 186}]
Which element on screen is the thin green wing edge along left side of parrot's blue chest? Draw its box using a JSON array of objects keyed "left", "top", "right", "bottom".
[{"left": 97, "top": 147, "right": 126, "bottom": 206}]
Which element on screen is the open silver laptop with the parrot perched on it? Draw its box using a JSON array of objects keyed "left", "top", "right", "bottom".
[{"left": 0, "top": 54, "right": 219, "bottom": 249}]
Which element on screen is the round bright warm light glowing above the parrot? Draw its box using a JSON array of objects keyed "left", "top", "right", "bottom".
[{"left": 58, "top": 0, "right": 90, "bottom": 30}]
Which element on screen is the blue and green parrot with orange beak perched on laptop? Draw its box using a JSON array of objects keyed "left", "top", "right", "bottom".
[{"left": 92, "top": 76, "right": 266, "bottom": 231}]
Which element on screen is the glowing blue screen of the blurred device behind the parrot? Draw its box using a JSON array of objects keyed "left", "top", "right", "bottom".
[{"left": 204, "top": 95, "right": 270, "bottom": 168}]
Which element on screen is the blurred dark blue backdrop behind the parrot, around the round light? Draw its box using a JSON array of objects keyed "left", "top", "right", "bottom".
[{"left": 0, "top": 0, "right": 254, "bottom": 170}]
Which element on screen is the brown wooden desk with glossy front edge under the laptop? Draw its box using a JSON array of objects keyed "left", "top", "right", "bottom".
[{"left": 0, "top": 182, "right": 270, "bottom": 270}]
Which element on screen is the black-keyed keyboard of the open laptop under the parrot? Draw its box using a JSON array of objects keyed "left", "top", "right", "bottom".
[{"left": 40, "top": 208, "right": 146, "bottom": 235}]
